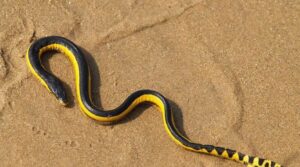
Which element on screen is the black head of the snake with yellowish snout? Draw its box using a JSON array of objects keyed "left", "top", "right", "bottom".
[{"left": 47, "top": 77, "right": 68, "bottom": 106}]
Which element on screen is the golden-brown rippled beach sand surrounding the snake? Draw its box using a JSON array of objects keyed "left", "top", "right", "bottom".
[{"left": 0, "top": 0, "right": 300, "bottom": 167}]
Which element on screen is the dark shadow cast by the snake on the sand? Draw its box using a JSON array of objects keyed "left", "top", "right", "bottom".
[{"left": 42, "top": 46, "right": 188, "bottom": 138}]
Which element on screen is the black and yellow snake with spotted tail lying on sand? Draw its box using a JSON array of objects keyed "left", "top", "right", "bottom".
[{"left": 26, "top": 36, "right": 282, "bottom": 167}]
